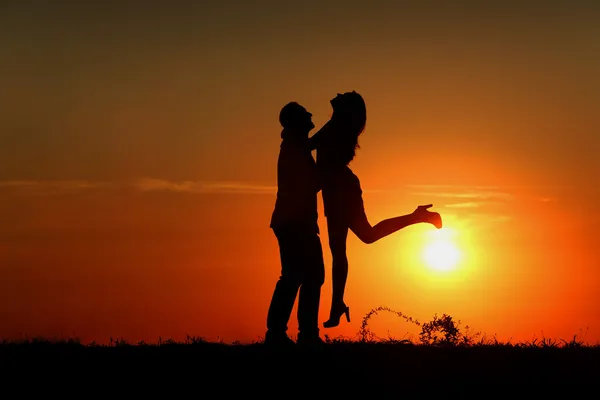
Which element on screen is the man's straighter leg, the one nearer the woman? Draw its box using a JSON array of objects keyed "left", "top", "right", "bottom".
[{"left": 298, "top": 233, "right": 325, "bottom": 342}]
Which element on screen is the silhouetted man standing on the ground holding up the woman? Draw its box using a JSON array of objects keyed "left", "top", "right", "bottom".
[{"left": 265, "top": 102, "right": 325, "bottom": 345}]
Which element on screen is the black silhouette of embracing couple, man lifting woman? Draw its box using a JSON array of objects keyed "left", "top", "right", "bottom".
[{"left": 265, "top": 91, "right": 442, "bottom": 345}]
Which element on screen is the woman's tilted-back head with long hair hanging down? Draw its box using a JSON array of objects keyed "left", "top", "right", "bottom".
[{"left": 331, "top": 91, "right": 367, "bottom": 164}]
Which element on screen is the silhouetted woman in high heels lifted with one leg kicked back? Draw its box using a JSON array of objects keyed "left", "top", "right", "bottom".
[{"left": 310, "top": 91, "right": 442, "bottom": 328}]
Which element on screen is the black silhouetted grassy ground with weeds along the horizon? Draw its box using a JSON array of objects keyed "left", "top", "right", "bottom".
[{"left": 0, "top": 307, "right": 600, "bottom": 398}]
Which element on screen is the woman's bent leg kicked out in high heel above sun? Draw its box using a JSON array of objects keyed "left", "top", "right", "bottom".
[{"left": 350, "top": 204, "right": 442, "bottom": 244}]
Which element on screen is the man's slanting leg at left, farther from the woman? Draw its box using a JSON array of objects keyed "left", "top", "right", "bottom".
[{"left": 265, "top": 231, "right": 303, "bottom": 341}]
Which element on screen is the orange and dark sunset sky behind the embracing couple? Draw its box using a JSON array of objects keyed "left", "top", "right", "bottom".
[{"left": 0, "top": 0, "right": 600, "bottom": 343}]
